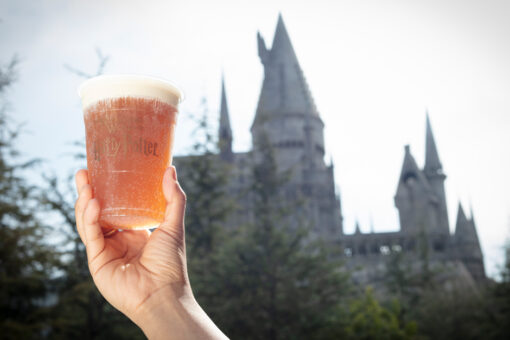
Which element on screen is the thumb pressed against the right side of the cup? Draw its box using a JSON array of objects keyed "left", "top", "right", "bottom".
[{"left": 160, "top": 166, "right": 186, "bottom": 236}]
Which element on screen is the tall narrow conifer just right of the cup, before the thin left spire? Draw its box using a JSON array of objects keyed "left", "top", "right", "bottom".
[{"left": 174, "top": 100, "right": 233, "bottom": 318}]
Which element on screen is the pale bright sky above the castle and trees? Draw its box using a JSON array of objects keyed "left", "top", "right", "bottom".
[{"left": 0, "top": 0, "right": 510, "bottom": 275}]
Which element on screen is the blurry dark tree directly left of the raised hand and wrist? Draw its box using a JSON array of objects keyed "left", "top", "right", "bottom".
[{"left": 39, "top": 53, "right": 145, "bottom": 339}]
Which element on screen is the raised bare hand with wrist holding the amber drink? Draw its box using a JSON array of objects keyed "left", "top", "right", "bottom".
[{"left": 75, "top": 167, "right": 225, "bottom": 339}]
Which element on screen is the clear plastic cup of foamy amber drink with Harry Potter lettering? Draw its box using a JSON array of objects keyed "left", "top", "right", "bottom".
[{"left": 78, "top": 75, "right": 182, "bottom": 229}]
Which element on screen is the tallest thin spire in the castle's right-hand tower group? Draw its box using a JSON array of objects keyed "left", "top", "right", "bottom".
[{"left": 423, "top": 112, "right": 450, "bottom": 237}]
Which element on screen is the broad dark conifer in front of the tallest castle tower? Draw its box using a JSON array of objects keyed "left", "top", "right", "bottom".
[{"left": 198, "top": 134, "right": 348, "bottom": 339}]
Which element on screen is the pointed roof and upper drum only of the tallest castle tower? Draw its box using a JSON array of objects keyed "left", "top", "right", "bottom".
[{"left": 251, "top": 15, "right": 325, "bottom": 170}]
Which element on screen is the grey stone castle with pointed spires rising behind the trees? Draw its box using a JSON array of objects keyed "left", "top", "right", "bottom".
[{"left": 176, "top": 15, "right": 485, "bottom": 283}]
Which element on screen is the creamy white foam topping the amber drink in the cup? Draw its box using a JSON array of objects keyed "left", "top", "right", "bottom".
[{"left": 78, "top": 75, "right": 183, "bottom": 109}]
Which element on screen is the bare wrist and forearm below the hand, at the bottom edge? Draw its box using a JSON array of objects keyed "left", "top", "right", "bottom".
[{"left": 133, "top": 288, "right": 227, "bottom": 340}]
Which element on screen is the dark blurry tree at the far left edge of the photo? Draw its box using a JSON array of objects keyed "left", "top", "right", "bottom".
[{"left": 0, "top": 58, "right": 59, "bottom": 339}]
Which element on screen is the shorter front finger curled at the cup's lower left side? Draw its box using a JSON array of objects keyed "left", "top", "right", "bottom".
[{"left": 83, "top": 199, "right": 105, "bottom": 263}]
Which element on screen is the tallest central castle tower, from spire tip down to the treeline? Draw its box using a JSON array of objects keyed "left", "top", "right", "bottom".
[{"left": 251, "top": 15, "right": 342, "bottom": 240}]
